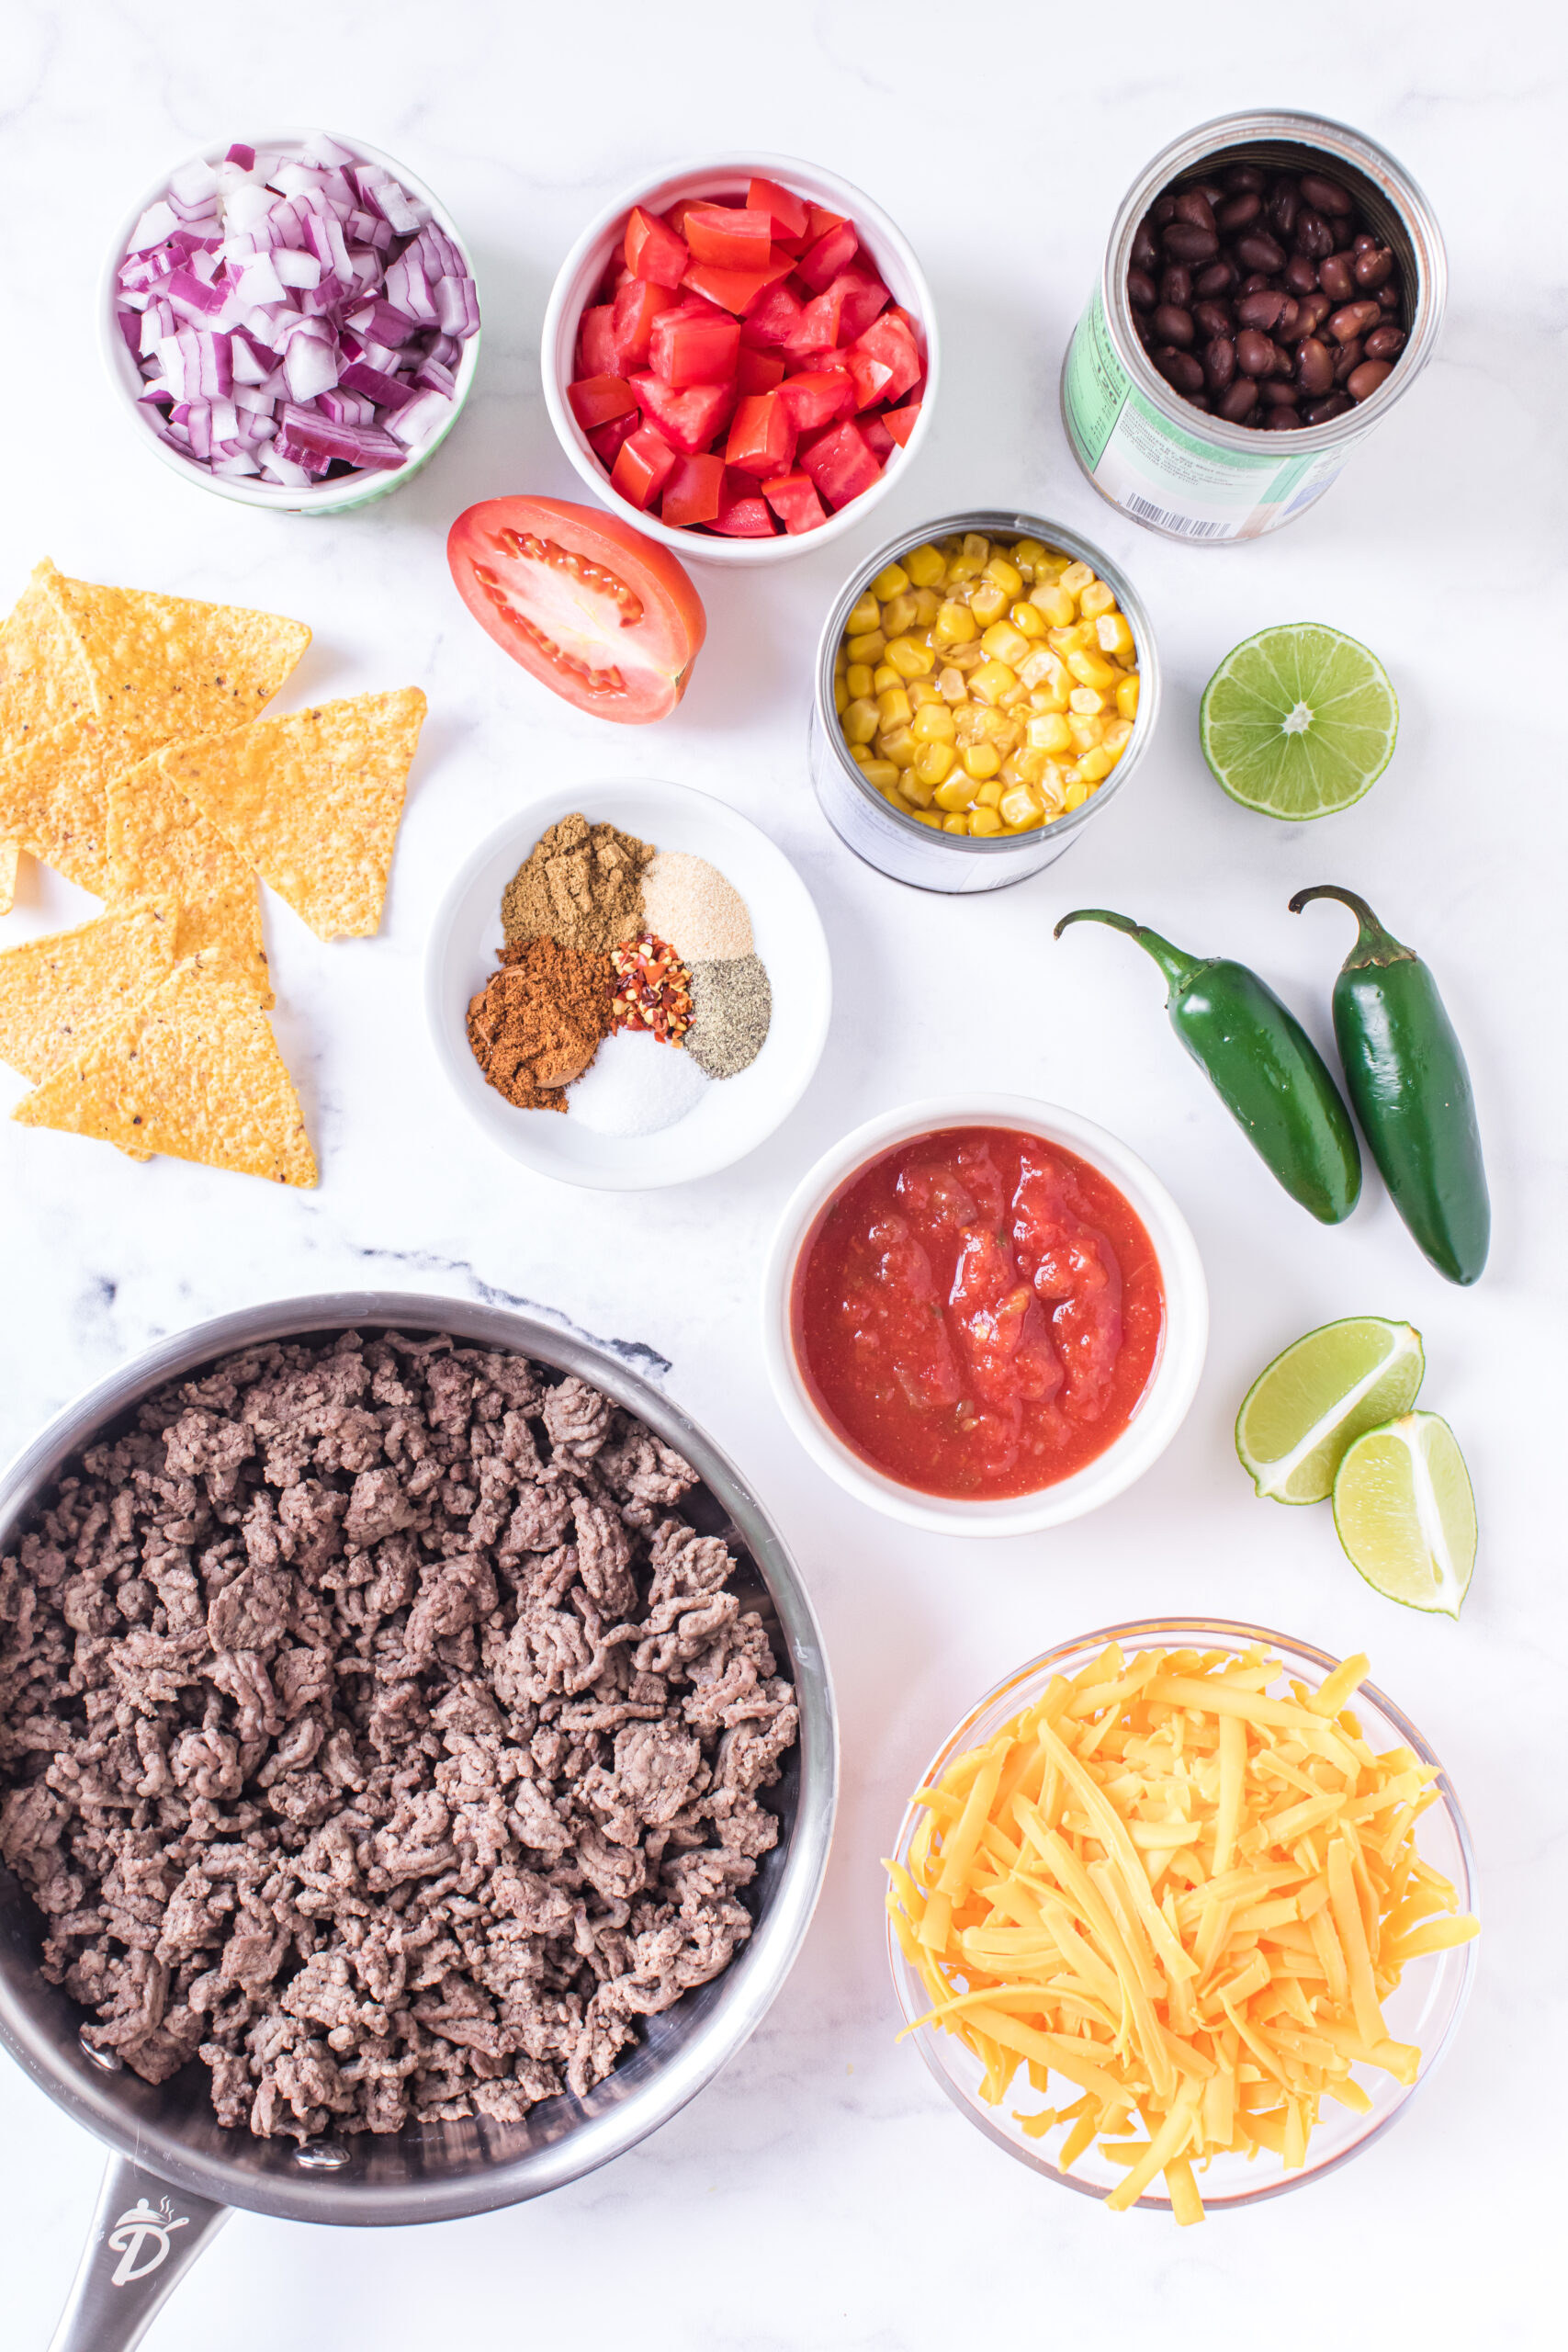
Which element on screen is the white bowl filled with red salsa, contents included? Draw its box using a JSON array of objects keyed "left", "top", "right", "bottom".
[{"left": 764, "top": 1093, "right": 1208, "bottom": 1536}]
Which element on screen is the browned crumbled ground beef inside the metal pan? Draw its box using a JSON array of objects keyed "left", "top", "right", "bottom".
[{"left": 0, "top": 1331, "right": 799, "bottom": 2141}]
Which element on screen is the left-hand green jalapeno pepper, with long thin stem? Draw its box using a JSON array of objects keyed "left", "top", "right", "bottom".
[{"left": 1055, "top": 906, "right": 1361, "bottom": 1226}]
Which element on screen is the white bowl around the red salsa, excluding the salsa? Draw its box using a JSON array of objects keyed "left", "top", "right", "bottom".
[{"left": 761, "top": 1093, "right": 1208, "bottom": 1536}]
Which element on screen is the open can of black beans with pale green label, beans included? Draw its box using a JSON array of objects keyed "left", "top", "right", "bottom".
[{"left": 1063, "top": 113, "right": 1448, "bottom": 546}]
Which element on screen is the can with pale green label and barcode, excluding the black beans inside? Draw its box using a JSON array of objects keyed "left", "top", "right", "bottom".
[{"left": 1063, "top": 113, "right": 1448, "bottom": 546}]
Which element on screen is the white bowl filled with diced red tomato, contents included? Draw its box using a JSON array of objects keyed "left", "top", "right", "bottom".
[{"left": 541, "top": 155, "right": 938, "bottom": 564}]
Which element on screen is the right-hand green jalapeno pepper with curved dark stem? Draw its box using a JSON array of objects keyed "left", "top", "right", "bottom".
[{"left": 1291, "top": 882, "right": 1493, "bottom": 1282}]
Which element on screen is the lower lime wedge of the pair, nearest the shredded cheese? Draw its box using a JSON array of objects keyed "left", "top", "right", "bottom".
[{"left": 1333, "top": 1414, "right": 1476, "bottom": 1616}]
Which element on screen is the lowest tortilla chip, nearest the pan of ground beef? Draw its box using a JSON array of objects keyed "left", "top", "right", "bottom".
[{"left": 12, "top": 957, "right": 315, "bottom": 1185}]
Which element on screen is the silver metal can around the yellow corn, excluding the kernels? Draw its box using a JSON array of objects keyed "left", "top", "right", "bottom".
[{"left": 816, "top": 505, "right": 1159, "bottom": 856}]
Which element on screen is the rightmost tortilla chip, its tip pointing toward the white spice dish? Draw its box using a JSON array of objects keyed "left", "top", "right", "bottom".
[{"left": 156, "top": 687, "right": 425, "bottom": 938}]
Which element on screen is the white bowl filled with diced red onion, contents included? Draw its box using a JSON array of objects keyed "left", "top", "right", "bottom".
[{"left": 101, "top": 130, "right": 479, "bottom": 515}]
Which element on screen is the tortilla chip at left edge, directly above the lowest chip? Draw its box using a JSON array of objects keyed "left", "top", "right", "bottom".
[{"left": 0, "top": 906, "right": 174, "bottom": 1082}]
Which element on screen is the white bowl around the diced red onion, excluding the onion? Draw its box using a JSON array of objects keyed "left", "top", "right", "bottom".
[{"left": 98, "top": 130, "right": 479, "bottom": 515}]
